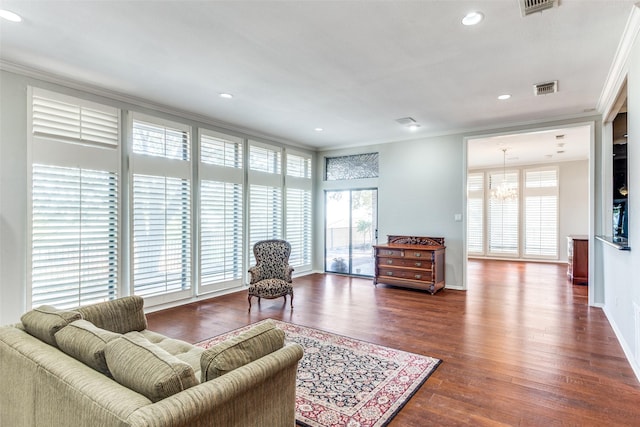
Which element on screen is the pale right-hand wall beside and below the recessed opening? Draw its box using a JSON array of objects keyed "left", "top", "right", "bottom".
[{"left": 596, "top": 5, "right": 640, "bottom": 378}]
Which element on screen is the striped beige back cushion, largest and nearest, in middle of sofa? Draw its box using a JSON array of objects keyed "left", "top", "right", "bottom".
[{"left": 104, "top": 332, "right": 198, "bottom": 402}]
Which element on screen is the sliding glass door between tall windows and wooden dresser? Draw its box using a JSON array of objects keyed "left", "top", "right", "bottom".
[{"left": 325, "top": 189, "right": 378, "bottom": 276}]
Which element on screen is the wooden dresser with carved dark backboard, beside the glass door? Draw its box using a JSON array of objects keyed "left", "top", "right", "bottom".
[{"left": 373, "top": 236, "right": 445, "bottom": 295}]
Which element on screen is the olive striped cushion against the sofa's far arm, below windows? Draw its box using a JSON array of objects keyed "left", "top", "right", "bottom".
[{"left": 77, "top": 296, "right": 147, "bottom": 334}]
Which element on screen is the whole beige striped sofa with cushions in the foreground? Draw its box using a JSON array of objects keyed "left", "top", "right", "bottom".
[{"left": 0, "top": 297, "right": 302, "bottom": 427}]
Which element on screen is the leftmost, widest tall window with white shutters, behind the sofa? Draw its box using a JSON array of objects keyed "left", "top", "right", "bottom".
[{"left": 28, "top": 88, "right": 120, "bottom": 308}]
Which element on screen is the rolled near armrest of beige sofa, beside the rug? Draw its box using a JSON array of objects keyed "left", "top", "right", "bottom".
[{"left": 128, "top": 343, "right": 303, "bottom": 427}]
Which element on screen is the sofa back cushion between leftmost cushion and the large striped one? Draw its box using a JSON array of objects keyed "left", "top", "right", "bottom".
[{"left": 55, "top": 320, "right": 121, "bottom": 376}]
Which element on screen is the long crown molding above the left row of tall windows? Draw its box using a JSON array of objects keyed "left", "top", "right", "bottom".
[{"left": 0, "top": 59, "right": 316, "bottom": 152}]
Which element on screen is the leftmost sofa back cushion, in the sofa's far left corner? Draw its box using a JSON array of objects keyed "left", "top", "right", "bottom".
[{"left": 20, "top": 305, "right": 82, "bottom": 346}]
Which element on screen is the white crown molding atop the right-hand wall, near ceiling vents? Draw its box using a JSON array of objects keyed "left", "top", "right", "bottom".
[{"left": 596, "top": 3, "right": 640, "bottom": 117}]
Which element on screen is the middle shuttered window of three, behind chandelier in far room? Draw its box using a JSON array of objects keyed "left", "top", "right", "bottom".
[{"left": 487, "top": 171, "right": 519, "bottom": 256}]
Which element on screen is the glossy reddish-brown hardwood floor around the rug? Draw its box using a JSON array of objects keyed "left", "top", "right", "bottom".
[{"left": 148, "top": 260, "right": 640, "bottom": 427}]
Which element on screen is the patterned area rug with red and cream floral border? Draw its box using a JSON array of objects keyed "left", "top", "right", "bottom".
[{"left": 198, "top": 320, "right": 441, "bottom": 427}]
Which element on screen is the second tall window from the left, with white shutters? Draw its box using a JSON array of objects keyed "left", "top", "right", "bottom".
[{"left": 131, "top": 113, "right": 191, "bottom": 296}]
